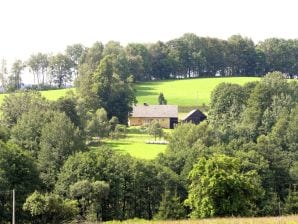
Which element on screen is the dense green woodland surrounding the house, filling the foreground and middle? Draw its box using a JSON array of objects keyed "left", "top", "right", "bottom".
[{"left": 0, "top": 69, "right": 298, "bottom": 224}]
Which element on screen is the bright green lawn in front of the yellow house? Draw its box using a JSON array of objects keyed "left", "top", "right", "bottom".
[{"left": 91, "top": 127, "right": 169, "bottom": 160}]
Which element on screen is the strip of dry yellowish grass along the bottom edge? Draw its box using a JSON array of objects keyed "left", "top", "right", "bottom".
[{"left": 102, "top": 215, "right": 298, "bottom": 224}]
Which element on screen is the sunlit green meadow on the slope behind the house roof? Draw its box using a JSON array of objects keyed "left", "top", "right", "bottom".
[{"left": 135, "top": 77, "right": 260, "bottom": 106}]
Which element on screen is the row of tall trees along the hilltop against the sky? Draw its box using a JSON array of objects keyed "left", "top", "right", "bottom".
[{"left": 0, "top": 33, "right": 298, "bottom": 91}]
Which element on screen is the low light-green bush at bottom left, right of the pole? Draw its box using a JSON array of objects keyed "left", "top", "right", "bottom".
[{"left": 23, "top": 191, "right": 78, "bottom": 224}]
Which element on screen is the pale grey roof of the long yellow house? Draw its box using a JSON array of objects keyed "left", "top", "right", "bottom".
[{"left": 131, "top": 105, "right": 178, "bottom": 117}]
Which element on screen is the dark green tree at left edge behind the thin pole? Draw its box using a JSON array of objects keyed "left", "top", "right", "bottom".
[{"left": 0, "top": 141, "right": 40, "bottom": 223}]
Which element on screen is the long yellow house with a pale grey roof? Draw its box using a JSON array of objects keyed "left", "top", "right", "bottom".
[{"left": 128, "top": 104, "right": 178, "bottom": 128}]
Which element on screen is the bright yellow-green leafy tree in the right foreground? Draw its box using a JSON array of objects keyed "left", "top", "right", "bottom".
[{"left": 186, "top": 154, "right": 262, "bottom": 218}]
